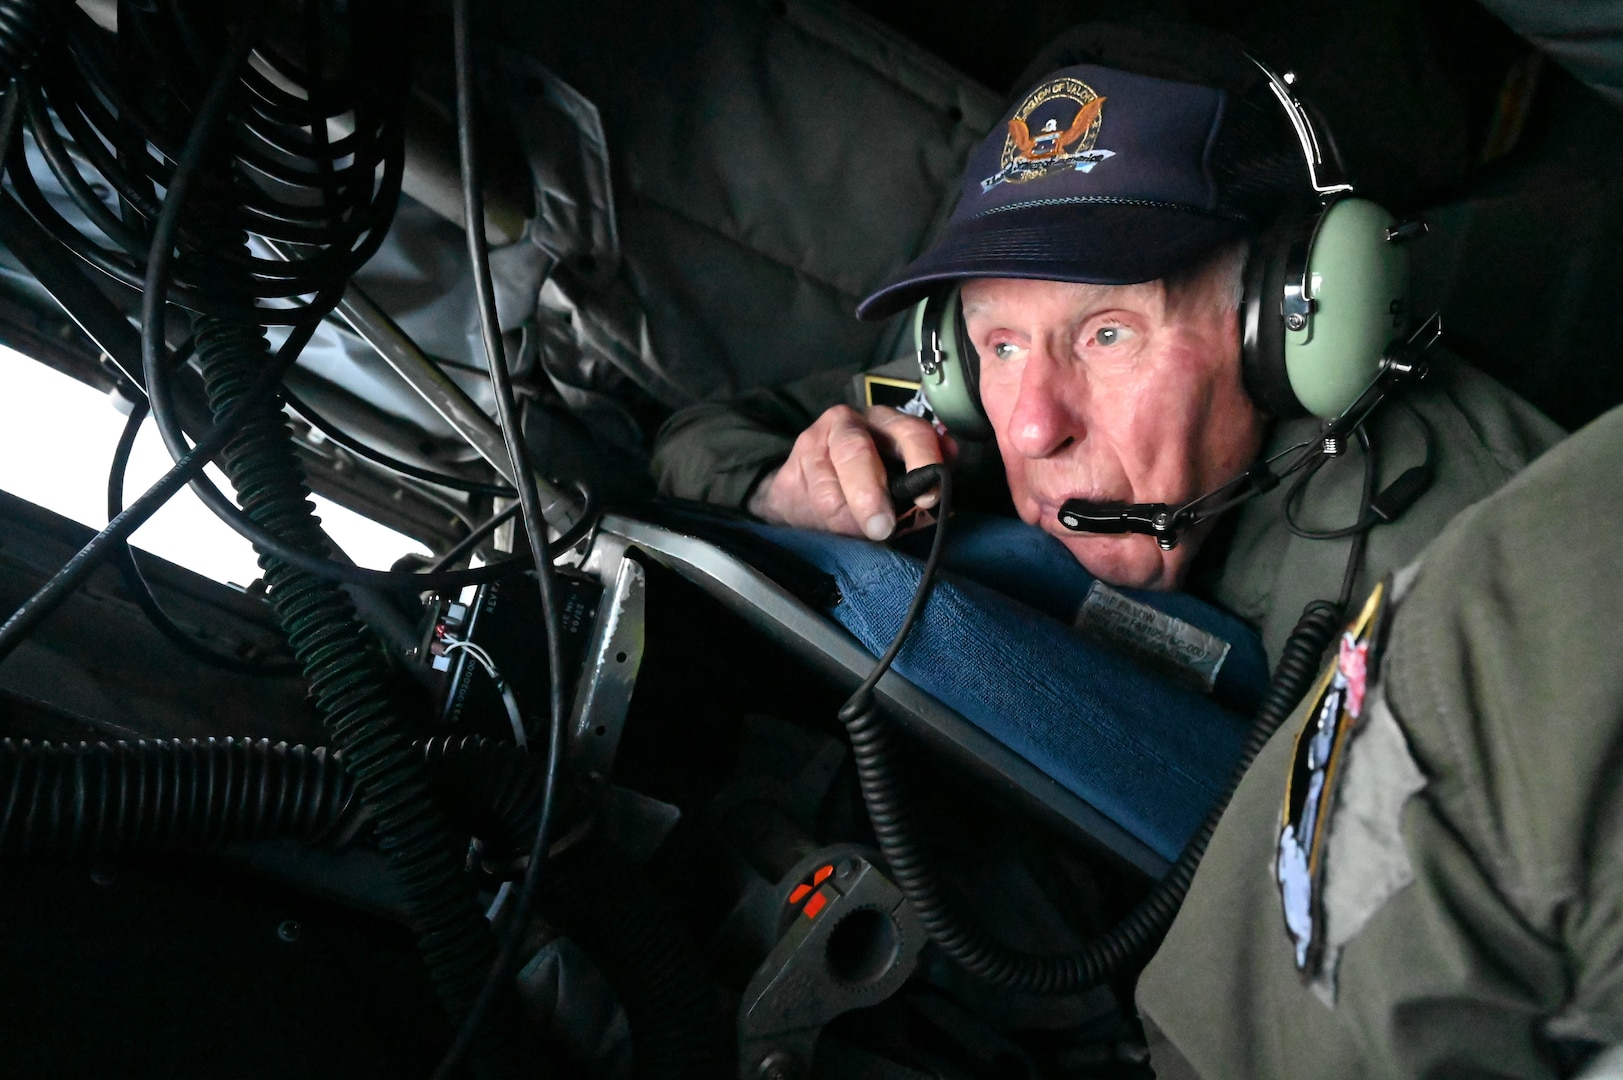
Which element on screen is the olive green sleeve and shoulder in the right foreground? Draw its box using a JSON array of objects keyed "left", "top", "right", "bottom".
[{"left": 1138, "top": 399, "right": 1623, "bottom": 1080}]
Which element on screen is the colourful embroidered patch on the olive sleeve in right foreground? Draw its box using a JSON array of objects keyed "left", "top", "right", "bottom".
[{"left": 1274, "top": 581, "right": 1386, "bottom": 979}]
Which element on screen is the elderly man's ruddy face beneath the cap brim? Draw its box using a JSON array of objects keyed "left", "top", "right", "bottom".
[{"left": 962, "top": 267, "right": 1263, "bottom": 590}]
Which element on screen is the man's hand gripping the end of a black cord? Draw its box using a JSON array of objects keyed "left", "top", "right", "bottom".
[{"left": 748, "top": 404, "right": 953, "bottom": 541}]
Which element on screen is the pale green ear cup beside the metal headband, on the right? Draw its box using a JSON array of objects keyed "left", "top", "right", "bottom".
[{"left": 1284, "top": 198, "right": 1409, "bottom": 417}]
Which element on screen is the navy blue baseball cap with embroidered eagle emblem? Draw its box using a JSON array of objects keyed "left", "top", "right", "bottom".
[{"left": 857, "top": 65, "right": 1258, "bottom": 318}]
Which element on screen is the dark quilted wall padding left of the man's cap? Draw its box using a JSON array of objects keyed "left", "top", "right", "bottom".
[{"left": 498, "top": 0, "right": 1003, "bottom": 409}]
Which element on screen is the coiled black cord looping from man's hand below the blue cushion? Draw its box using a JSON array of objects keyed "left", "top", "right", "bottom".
[{"left": 839, "top": 466, "right": 1342, "bottom": 994}]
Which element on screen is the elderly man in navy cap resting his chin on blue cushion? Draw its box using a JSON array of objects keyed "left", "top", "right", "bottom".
[{"left": 654, "top": 26, "right": 1561, "bottom": 656}]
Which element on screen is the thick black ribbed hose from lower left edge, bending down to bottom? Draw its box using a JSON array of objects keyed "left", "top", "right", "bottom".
[{"left": 0, "top": 736, "right": 732, "bottom": 1080}]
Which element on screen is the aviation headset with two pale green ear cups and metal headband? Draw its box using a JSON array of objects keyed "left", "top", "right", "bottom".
[{"left": 914, "top": 57, "right": 1425, "bottom": 442}]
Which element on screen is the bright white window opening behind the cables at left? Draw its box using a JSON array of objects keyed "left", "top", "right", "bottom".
[{"left": 0, "top": 346, "right": 428, "bottom": 585}]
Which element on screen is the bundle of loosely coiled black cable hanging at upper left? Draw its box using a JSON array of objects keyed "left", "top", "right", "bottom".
[{"left": 6, "top": 2, "right": 409, "bottom": 325}]
